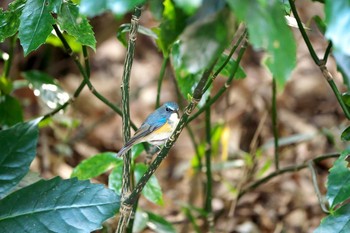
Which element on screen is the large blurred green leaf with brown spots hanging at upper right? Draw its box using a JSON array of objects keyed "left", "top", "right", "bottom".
[{"left": 227, "top": 0, "right": 296, "bottom": 87}]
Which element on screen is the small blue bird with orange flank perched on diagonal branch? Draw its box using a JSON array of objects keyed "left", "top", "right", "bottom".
[{"left": 117, "top": 102, "right": 180, "bottom": 157}]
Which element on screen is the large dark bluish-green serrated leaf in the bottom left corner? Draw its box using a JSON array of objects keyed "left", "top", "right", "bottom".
[{"left": 0, "top": 177, "right": 120, "bottom": 232}]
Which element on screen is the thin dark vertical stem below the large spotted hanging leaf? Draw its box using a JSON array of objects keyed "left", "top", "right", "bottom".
[{"left": 271, "top": 78, "right": 279, "bottom": 170}]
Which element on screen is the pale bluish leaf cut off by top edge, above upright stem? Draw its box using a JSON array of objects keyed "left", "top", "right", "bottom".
[{"left": 80, "top": 0, "right": 145, "bottom": 17}]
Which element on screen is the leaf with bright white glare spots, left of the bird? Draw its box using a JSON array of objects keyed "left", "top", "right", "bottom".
[{"left": 22, "top": 70, "right": 69, "bottom": 109}]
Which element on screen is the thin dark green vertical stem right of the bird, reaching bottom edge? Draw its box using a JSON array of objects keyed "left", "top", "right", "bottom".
[{"left": 204, "top": 97, "right": 214, "bottom": 232}]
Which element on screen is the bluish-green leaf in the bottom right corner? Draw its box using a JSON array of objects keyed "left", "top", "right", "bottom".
[{"left": 314, "top": 204, "right": 350, "bottom": 233}]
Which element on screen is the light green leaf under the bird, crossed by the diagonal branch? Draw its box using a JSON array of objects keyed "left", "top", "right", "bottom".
[{"left": 135, "top": 163, "right": 163, "bottom": 205}]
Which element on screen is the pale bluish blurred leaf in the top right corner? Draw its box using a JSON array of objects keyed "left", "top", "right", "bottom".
[{"left": 325, "top": 0, "right": 350, "bottom": 56}]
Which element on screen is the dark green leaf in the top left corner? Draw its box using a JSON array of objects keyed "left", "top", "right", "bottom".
[{"left": 0, "top": 0, "right": 25, "bottom": 42}]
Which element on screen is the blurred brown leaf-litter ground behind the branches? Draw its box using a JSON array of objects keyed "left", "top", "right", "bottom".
[{"left": 0, "top": 1, "right": 346, "bottom": 233}]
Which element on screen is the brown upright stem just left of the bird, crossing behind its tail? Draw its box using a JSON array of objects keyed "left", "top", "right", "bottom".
[{"left": 117, "top": 7, "right": 141, "bottom": 232}]
